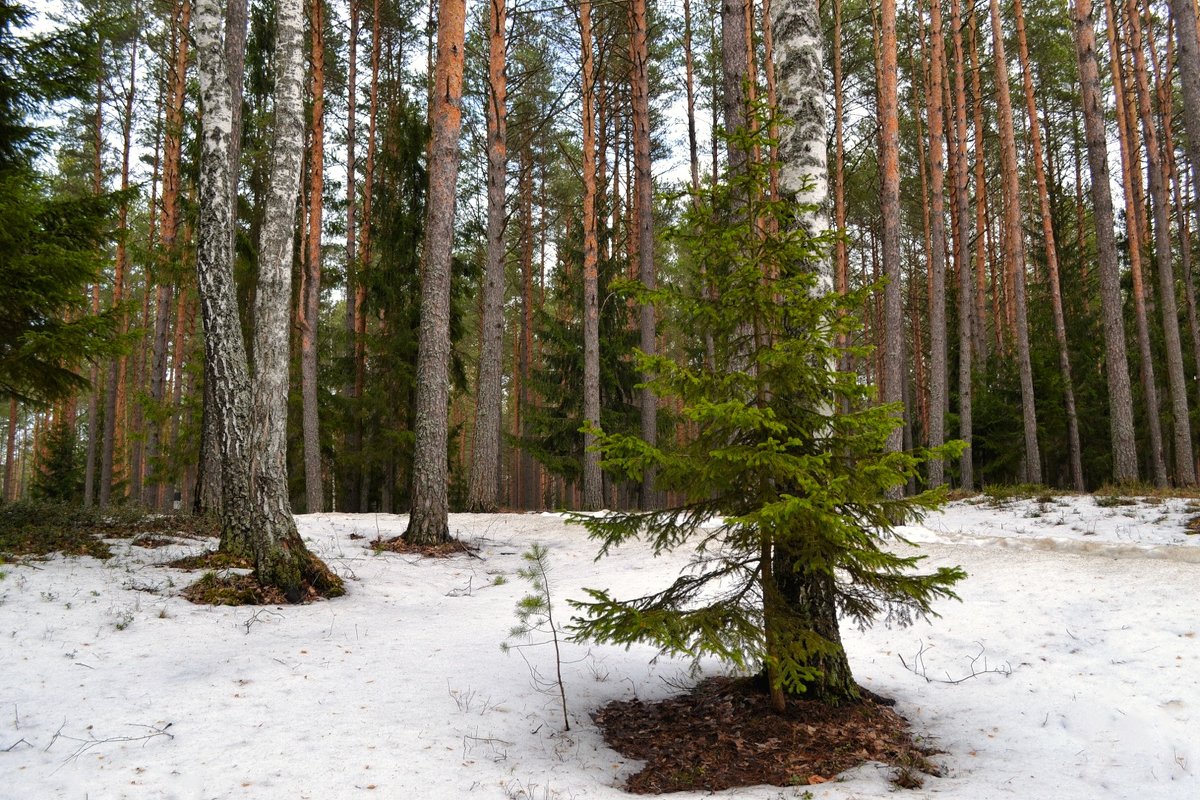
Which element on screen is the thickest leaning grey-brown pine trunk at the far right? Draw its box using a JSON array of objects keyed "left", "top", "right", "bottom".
[{"left": 1073, "top": 0, "right": 1138, "bottom": 483}]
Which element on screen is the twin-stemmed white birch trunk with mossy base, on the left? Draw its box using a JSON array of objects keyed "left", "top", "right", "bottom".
[{"left": 193, "top": 0, "right": 343, "bottom": 594}]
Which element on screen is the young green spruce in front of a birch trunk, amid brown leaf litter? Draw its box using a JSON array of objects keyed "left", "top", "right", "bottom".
[{"left": 574, "top": 124, "right": 965, "bottom": 710}]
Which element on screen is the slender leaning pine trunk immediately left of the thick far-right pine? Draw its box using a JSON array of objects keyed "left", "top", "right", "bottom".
[{"left": 1013, "top": 0, "right": 1084, "bottom": 492}]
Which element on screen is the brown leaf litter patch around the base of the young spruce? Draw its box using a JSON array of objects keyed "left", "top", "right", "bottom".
[{"left": 593, "top": 678, "right": 937, "bottom": 794}]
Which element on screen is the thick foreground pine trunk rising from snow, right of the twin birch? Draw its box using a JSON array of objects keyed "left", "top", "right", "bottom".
[{"left": 404, "top": 0, "right": 466, "bottom": 545}]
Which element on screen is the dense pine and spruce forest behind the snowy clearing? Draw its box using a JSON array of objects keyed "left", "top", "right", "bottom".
[{"left": 0, "top": 0, "right": 1200, "bottom": 512}]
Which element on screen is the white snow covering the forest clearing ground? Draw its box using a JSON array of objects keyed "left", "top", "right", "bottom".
[{"left": 0, "top": 497, "right": 1200, "bottom": 800}]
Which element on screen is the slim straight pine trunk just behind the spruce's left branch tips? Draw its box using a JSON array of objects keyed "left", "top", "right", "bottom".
[{"left": 580, "top": 0, "right": 604, "bottom": 511}]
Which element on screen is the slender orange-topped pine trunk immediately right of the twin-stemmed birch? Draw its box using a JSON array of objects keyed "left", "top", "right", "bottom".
[{"left": 296, "top": 0, "right": 325, "bottom": 513}]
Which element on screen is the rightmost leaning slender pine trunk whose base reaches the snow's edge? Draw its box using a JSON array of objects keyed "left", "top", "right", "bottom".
[{"left": 1114, "top": 1, "right": 1196, "bottom": 486}]
